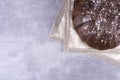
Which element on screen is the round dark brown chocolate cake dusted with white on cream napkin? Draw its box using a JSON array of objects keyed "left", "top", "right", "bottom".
[{"left": 72, "top": 0, "right": 120, "bottom": 50}]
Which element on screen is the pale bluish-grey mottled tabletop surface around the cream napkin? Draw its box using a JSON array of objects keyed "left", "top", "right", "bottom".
[{"left": 0, "top": 0, "right": 120, "bottom": 80}]
